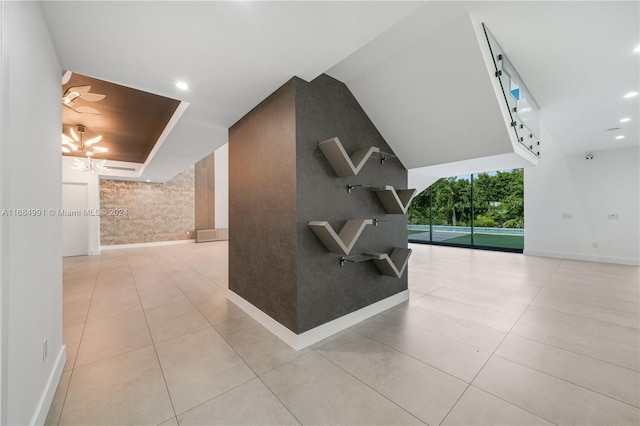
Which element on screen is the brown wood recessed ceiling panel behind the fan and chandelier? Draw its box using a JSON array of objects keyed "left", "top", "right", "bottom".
[{"left": 62, "top": 73, "right": 180, "bottom": 163}]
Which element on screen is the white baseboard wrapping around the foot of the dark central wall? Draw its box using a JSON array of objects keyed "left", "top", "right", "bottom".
[{"left": 227, "top": 290, "right": 409, "bottom": 351}]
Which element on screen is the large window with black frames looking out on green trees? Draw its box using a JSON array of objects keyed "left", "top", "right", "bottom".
[{"left": 408, "top": 169, "right": 524, "bottom": 252}]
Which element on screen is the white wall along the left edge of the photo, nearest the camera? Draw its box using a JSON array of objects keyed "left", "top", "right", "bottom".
[{"left": 0, "top": 1, "right": 65, "bottom": 425}]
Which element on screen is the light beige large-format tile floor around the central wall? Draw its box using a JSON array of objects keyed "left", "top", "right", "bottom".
[{"left": 47, "top": 242, "right": 640, "bottom": 425}]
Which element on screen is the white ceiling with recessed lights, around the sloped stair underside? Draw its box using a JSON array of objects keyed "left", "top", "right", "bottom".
[{"left": 41, "top": 1, "right": 640, "bottom": 180}]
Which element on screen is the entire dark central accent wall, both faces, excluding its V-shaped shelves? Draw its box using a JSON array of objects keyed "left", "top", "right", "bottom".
[{"left": 229, "top": 75, "right": 407, "bottom": 334}]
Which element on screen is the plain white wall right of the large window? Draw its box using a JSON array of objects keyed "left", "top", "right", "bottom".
[{"left": 524, "top": 129, "right": 640, "bottom": 265}]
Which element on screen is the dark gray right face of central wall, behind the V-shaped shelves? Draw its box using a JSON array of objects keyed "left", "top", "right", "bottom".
[{"left": 294, "top": 75, "right": 407, "bottom": 333}]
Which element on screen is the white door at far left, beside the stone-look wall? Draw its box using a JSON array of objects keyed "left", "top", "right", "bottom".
[{"left": 62, "top": 182, "right": 89, "bottom": 256}]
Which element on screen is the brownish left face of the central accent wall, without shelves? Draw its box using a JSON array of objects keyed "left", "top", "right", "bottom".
[{"left": 229, "top": 82, "right": 297, "bottom": 332}]
